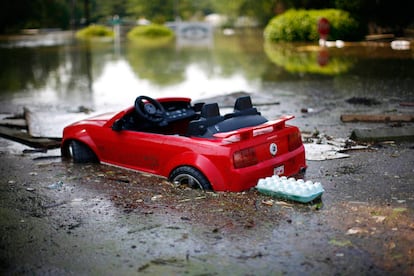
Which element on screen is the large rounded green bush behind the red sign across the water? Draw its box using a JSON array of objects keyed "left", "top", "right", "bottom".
[{"left": 264, "top": 9, "right": 362, "bottom": 41}]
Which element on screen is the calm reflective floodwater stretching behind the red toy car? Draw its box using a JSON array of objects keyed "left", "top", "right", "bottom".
[{"left": 0, "top": 28, "right": 414, "bottom": 113}]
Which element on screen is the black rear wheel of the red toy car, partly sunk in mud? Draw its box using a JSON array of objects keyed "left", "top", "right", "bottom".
[{"left": 169, "top": 166, "right": 212, "bottom": 191}]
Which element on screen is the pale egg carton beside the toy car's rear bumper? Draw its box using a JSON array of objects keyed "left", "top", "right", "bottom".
[{"left": 256, "top": 175, "right": 325, "bottom": 203}]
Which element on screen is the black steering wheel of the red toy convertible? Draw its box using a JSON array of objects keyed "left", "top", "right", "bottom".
[{"left": 135, "top": 96, "right": 166, "bottom": 125}]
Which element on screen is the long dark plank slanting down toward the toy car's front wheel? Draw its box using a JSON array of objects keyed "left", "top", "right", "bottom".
[{"left": 0, "top": 126, "right": 60, "bottom": 149}]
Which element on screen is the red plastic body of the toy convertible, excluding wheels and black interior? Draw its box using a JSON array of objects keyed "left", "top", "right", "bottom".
[{"left": 62, "top": 98, "right": 306, "bottom": 192}]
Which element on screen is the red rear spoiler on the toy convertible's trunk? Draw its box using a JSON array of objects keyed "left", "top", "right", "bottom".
[{"left": 213, "top": 115, "right": 295, "bottom": 142}]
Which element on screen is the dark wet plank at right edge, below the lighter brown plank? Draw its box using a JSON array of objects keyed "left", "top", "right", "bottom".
[{"left": 350, "top": 127, "right": 414, "bottom": 142}]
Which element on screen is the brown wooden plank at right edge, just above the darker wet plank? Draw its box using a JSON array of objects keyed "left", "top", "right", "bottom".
[{"left": 341, "top": 114, "right": 414, "bottom": 123}]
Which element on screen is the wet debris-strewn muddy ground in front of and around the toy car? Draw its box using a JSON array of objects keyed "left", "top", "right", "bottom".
[{"left": 0, "top": 91, "right": 414, "bottom": 275}]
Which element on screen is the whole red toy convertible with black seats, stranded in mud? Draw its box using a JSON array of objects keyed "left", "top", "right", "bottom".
[{"left": 61, "top": 96, "right": 306, "bottom": 192}]
